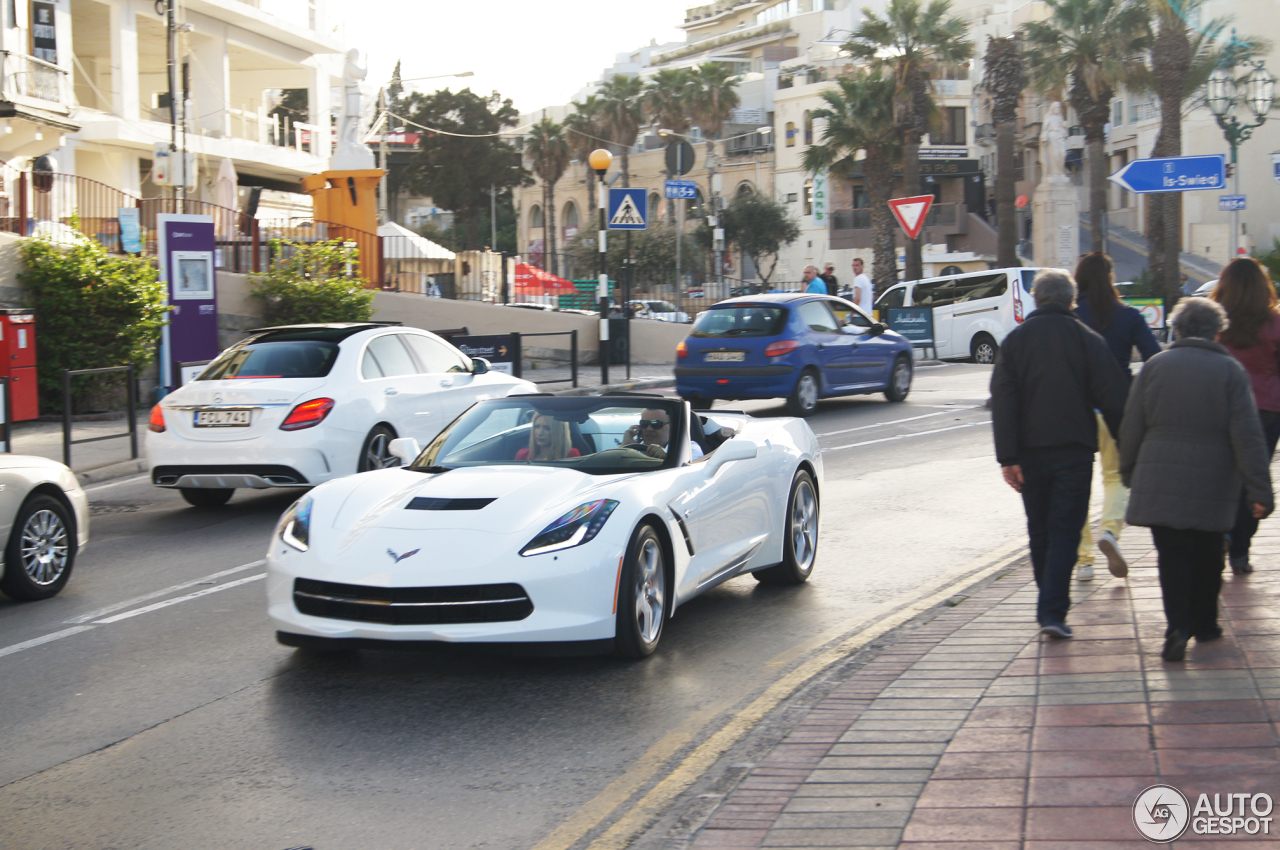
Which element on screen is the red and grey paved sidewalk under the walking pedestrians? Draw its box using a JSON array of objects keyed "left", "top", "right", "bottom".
[{"left": 690, "top": 526, "right": 1280, "bottom": 850}]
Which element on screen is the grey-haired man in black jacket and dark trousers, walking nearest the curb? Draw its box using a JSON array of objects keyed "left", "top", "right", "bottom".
[{"left": 991, "top": 269, "right": 1128, "bottom": 638}]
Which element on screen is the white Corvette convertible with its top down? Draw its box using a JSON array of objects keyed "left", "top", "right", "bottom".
[{"left": 266, "top": 393, "right": 822, "bottom": 658}]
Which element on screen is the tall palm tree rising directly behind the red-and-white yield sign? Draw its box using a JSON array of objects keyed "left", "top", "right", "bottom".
[{"left": 845, "top": 0, "right": 973, "bottom": 280}]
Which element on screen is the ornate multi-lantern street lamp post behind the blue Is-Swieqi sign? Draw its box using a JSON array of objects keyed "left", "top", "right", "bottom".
[{"left": 1204, "top": 29, "right": 1276, "bottom": 260}]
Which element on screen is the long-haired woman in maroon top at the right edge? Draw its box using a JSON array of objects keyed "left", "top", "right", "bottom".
[{"left": 1210, "top": 257, "right": 1280, "bottom": 573}]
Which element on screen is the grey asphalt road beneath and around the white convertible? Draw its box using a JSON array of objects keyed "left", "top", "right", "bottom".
[{"left": 0, "top": 364, "right": 1024, "bottom": 850}]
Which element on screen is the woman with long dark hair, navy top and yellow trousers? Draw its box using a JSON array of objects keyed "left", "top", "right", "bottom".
[{"left": 1075, "top": 251, "right": 1160, "bottom": 581}]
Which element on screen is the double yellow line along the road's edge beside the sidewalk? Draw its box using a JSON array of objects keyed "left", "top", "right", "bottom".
[{"left": 532, "top": 541, "right": 1027, "bottom": 850}]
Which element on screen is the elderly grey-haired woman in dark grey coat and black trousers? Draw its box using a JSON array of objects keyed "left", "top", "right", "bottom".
[{"left": 1120, "top": 298, "right": 1274, "bottom": 661}]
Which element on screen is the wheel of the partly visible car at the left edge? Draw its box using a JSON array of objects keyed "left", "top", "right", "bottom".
[{"left": 0, "top": 494, "right": 76, "bottom": 602}]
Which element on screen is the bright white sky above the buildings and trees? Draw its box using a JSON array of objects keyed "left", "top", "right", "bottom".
[{"left": 328, "top": 0, "right": 709, "bottom": 113}]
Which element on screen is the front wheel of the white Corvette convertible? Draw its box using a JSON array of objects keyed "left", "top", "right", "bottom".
[{"left": 613, "top": 525, "right": 667, "bottom": 658}]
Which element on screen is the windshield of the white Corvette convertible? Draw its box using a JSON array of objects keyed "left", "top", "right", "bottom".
[{"left": 410, "top": 396, "right": 686, "bottom": 475}]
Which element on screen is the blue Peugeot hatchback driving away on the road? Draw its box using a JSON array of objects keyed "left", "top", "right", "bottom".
[{"left": 676, "top": 293, "right": 914, "bottom": 416}]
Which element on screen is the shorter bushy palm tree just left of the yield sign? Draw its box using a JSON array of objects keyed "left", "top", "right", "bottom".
[{"left": 801, "top": 70, "right": 902, "bottom": 292}]
